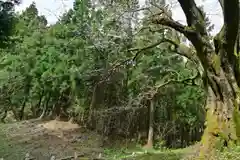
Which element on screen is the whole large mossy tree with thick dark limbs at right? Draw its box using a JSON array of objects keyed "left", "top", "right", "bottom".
[{"left": 152, "top": 0, "right": 240, "bottom": 159}]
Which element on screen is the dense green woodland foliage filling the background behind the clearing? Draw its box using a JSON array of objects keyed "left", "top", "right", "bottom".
[{"left": 0, "top": 0, "right": 204, "bottom": 150}]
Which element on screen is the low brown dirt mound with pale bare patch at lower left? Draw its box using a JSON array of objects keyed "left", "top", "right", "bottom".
[{"left": 0, "top": 120, "right": 103, "bottom": 160}]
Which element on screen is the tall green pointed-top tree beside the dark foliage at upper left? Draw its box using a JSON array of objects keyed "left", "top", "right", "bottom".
[{"left": 1, "top": 3, "right": 46, "bottom": 120}]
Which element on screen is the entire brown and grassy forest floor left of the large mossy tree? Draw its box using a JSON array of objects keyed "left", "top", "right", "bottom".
[{"left": 0, "top": 120, "right": 196, "bottom": 160}]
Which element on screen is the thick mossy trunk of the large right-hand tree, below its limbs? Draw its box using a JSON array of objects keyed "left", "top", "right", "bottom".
[{"left": 190, "top": 49, "right": 240, "bottom": 160}]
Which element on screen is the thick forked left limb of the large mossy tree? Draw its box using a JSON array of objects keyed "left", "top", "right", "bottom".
[{"left": 152, "top": 0, "right": 208, "bottom": 62}]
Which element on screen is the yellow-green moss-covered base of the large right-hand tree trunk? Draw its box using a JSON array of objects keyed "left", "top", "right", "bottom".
[{"left": 199, "top": 96, "right": 240, "bottom": 160}]
